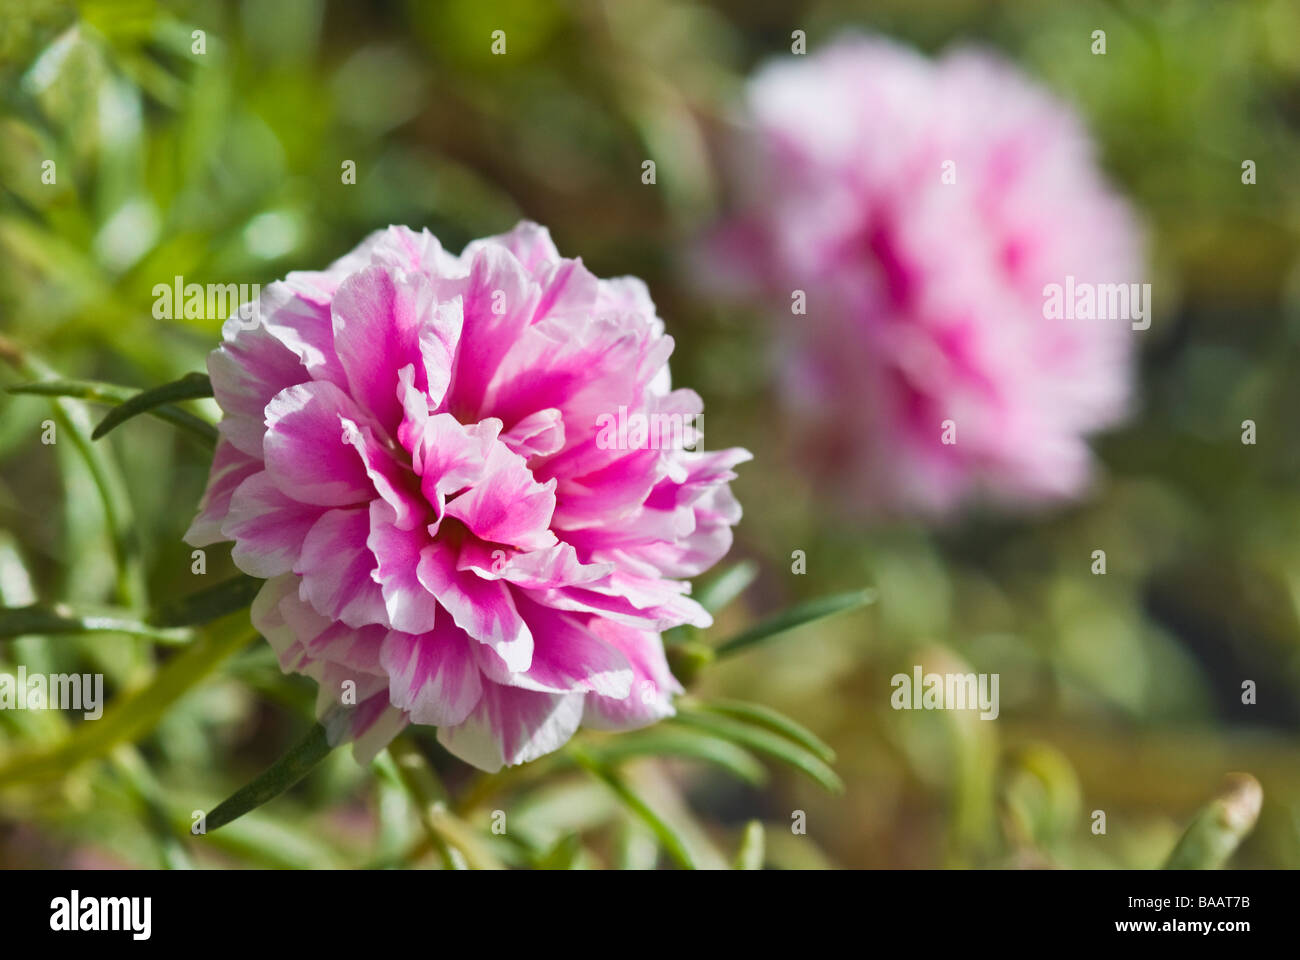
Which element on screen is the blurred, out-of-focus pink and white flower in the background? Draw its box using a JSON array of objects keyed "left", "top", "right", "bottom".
[{"left": 711, "top": 38, "right": 1149, "bottom": 513}]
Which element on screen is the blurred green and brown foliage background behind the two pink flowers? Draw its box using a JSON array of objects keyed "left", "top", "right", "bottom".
[{"left": 0, "top": 0, "right": 1300, "bottom": 868}]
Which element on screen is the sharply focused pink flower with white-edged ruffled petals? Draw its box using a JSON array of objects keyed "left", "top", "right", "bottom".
[{"left": 186, "top": 224, "right": 749, "bottom": 770}]
